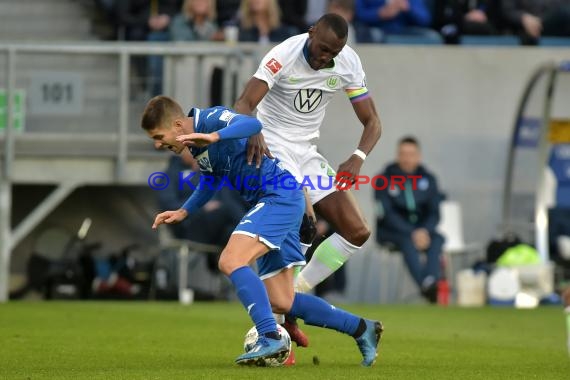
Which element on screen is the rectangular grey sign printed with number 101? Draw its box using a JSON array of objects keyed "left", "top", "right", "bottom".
[{"left": 29, "top": 71, "right": 83, "bottom": 116}]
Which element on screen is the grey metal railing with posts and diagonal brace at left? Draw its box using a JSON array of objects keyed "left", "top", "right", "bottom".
[{"left": 0, "top": 42, "right": 259, "bottom": 302}]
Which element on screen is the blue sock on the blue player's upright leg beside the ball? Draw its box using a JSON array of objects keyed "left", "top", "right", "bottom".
[{"left": 230, "top": 266, "right": 278, "bottom": 335}]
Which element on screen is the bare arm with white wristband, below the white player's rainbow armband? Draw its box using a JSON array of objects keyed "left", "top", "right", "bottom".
[{"left": 338, "top": 97, "right": 382, "bottom": 178}]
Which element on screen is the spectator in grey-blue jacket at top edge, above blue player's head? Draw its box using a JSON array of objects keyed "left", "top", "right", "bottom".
[{"left": 169, "top": 0, "right": 223, "bottom": 41}]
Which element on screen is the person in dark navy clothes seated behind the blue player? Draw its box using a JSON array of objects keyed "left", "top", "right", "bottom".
[{"left": 157, "top": 150, "right": 246, "bottom": 251}]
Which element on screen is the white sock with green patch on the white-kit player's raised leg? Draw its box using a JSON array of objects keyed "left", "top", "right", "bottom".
[{"left": 295, "top": 233, "right": 360, "bottom": 293}]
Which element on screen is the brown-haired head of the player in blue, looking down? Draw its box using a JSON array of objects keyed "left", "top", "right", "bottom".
[{"left": 141, "top": 96, "right": 186, "bottom": 154}]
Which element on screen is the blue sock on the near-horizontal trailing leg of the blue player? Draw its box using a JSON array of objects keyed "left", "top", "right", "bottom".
[{"left": 289, "top": 293, "right": 361, "bottom": 336}]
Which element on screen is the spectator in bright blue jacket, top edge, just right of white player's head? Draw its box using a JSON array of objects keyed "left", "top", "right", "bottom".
[{"left": 350, "top": 0, "right": 441, "bottom": 43}]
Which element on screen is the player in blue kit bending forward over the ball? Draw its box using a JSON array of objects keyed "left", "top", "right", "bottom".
[{"left": 141, "top": 96, "right": 382, "bottom": 366}]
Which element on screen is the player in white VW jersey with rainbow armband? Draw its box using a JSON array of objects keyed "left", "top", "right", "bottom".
[{"left": 235, "top": 14, "right": 381, "bottom": 346}]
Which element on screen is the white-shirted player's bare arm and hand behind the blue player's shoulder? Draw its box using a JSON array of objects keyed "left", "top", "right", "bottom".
[{"left": 234, "top": 77, "right": 273, "bottom": 167}]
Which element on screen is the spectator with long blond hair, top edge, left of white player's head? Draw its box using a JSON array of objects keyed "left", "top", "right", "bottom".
[{"left": 239, "top": 0, "right": 290, "bottom": 44}]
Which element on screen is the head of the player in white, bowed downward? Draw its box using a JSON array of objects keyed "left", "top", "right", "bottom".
[{"left": 309, "top": 13, "right": 348, "bottom": 70}]
